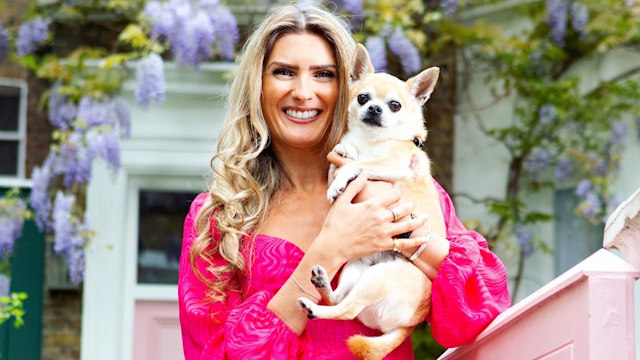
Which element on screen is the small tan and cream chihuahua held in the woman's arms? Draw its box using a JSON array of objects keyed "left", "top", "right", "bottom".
[{"left": 298, "top": 45, "right": 446, "bottom": 359}]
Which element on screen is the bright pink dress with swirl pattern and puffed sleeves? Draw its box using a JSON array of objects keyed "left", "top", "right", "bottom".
[{"left": 178, "top": 184, "right": 511, "bottom": 360}]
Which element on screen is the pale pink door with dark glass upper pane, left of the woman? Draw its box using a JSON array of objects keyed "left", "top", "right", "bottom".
[{"left": 132, "top": 189, "right": 196, "bottom": 360}]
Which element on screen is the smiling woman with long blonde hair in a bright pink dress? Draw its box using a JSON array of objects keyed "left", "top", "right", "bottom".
[{"left": 179, "top": 6, "right": 510, "bottom": 360}]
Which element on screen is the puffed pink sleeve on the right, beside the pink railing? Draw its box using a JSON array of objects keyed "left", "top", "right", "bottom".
[{"left": 428, "top": 183, "right": 511, "bottom": 347}]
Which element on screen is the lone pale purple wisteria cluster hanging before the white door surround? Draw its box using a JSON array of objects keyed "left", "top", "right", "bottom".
[{"left": 135, "top": 53, "right": 166, "bottom": 107}]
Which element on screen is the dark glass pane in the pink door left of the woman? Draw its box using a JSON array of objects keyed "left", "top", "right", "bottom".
[{"left": 138, "top": 190, "right": 197, "bottom": 284}]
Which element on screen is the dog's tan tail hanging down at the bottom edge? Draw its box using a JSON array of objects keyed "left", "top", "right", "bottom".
[{"left": 347, "top": 326, "right": 415, "bottom": 360}]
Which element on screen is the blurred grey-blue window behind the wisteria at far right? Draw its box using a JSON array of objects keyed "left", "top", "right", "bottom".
[{"left": 554, "top": 188, "right": 604, "bottom": 276}]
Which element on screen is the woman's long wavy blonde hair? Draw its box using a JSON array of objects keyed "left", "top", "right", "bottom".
[{"left": 190, "top": 5, "right": 355, "bottom": 301}]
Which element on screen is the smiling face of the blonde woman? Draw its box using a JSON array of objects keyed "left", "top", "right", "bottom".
[{"left": 262, "top": 33, "right": 338, "bottom": 151}]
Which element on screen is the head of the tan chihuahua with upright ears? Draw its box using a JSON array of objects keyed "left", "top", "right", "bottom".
[{"left": 348, "top": 44, "right": 440, "bottom": 142}]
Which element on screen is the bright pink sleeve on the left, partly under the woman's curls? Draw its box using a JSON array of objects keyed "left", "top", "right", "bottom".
[{"left": 178, "top": 194, "right": 310, "bottom": 360}]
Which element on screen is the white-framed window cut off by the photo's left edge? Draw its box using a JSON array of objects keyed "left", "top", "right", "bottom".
[{"left": 0, "top": 79, "right": 27, "bottom": 178}]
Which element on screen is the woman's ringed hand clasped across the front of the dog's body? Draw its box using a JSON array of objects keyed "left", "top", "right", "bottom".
[{"left": 309, "top": 172, "right": 426, "bottom": 272}]
